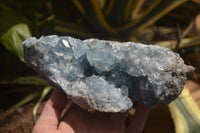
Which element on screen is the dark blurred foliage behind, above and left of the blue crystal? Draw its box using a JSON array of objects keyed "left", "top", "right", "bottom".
[{"left": 0, "top": 0, "right": 200, "bottom": 132}]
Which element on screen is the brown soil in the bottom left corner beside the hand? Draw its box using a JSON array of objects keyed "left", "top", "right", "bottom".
[{"left": 0, "top": 102, "right": 45, "bottom": 133}]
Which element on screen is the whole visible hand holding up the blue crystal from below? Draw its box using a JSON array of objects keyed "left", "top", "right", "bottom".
[{"left": 32, "top": 88, "right": 149, "bottom": 133}]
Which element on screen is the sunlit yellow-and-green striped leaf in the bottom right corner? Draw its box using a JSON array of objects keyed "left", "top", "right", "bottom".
[{"left": 169, "top": 87, "right": 200, "bottom": 133}]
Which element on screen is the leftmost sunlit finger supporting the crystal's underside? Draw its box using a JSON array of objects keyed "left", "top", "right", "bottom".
[{"left": 33, "top": 88, "right": 67, "bottom": 131}]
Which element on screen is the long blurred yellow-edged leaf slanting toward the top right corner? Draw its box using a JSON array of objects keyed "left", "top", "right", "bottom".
[{"left": 119, "top": 0, "right": 187, "bottom": 34}]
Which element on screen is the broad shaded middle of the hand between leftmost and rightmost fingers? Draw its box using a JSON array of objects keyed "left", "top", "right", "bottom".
[{"left": 59, "top": 104, "right": 126, "bottom": 133}]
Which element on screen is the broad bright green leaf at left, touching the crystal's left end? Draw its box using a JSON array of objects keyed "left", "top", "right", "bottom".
[{"left": 0, "top": 10, "right": 31, "bottom": 62}]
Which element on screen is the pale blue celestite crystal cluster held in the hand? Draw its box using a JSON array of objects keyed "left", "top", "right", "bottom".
[{"left": 23, "top": 35, "right": 194, "bottom": 112}]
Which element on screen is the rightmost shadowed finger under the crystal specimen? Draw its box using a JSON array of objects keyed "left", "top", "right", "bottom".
[{"left": 126, "top": 103, "right": 149, "bottom": 133}]
